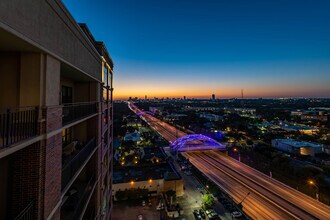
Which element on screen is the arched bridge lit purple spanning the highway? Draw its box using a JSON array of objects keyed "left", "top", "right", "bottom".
[{"left": 170, "top": 134, "right": 226, "bottom": 152}]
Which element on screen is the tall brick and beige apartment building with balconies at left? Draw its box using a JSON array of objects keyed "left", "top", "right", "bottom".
[{"left": 0, "top": 0, "right": 113, "bottom": 220}]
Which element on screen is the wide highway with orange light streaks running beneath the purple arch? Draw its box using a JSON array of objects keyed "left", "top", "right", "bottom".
[{"left": 129, "top": 103, "right": 330, "bottom": 220}]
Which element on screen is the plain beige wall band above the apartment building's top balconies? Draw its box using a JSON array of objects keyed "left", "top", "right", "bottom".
[{"left": 0, "top": 0, "right": 102, "bottom": 81}]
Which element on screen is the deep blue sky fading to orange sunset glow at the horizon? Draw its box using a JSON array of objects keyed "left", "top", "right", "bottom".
[{"left": 64, "top": 0, "right": 330, "bottom": 99}]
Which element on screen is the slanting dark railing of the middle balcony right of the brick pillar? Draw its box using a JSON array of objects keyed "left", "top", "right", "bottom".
[{"left": 62, "top": 138, "right": 96, "bottom": 190}]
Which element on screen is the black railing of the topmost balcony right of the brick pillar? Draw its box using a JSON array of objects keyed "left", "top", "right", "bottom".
[{"left": 62, "top": 102, "right": 97, "bottom": 125}]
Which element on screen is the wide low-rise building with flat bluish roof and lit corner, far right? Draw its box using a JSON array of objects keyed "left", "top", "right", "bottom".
[{"left": 272, "top": 139, "right": 323, "bottom": 156}]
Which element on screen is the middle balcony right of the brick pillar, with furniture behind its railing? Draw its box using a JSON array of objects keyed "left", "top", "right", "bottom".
[{"left": 62, "top": 138, "right": 96, "bottom": 190}]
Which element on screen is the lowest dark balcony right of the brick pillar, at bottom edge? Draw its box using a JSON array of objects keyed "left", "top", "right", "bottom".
[{"left": 61, "top": 174, "right": 96, "bottom": 220}]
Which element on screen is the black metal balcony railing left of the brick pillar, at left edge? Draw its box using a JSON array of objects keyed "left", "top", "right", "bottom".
[{"left": 0, "top": 107, "right": 38, "bottom": 148}]
